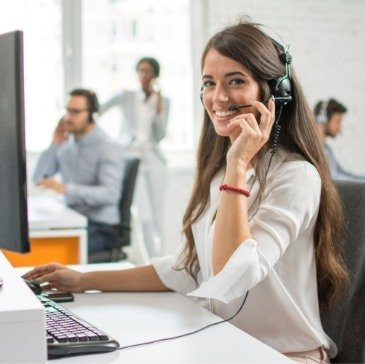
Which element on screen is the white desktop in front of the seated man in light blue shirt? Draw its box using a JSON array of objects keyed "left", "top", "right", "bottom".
[{"left": 28, "top": 194, "right": 87, "bottom": 231}]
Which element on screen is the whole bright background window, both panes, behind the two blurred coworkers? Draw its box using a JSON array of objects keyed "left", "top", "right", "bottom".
[{"left": 0, "top": 0, "right": 193, "bottom": 152}]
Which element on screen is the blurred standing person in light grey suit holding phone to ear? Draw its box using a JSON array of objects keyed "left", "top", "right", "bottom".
[{"left": 100, "top": 57, "right": 169, "bottom": 257}]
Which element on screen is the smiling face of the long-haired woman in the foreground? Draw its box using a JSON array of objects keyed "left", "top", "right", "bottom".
[{"left": 202, "top": 48, "right": 261, "bottom": 140}]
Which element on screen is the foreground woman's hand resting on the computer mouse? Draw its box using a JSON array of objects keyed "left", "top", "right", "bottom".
[{"left": 23, "top": 263, "right": 87, "bottom": 293}]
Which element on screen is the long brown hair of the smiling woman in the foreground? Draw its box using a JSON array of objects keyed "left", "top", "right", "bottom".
[{"left": 177, "top": 20, "right": 348, "bottom": 310}]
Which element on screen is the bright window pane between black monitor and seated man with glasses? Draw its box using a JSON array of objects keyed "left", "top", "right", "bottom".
[{"left": 0, "top": 0, "right": 64, "bottom": 151}]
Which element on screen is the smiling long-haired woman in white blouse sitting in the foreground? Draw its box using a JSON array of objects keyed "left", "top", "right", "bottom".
[{"left": 26, "top": 21, "right": 347, "bottom": 363}]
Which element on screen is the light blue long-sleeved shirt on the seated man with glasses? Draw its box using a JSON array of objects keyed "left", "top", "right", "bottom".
[{"left": 33, "top": 126, "right": 124, "bottom": 224}]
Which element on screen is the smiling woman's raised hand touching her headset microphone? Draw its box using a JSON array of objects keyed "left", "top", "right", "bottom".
[{"left": 227, "top": 99, "right": 275, "bottom": 168}]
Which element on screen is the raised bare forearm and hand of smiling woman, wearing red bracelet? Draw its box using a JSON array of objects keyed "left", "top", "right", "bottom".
[{"left": 213, "top": 99, "right": 275, "bottom": 274}]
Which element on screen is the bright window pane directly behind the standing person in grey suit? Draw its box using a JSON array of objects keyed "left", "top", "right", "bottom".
[{"left": 82, "top": 0, "right": 193, "bottom": 150}]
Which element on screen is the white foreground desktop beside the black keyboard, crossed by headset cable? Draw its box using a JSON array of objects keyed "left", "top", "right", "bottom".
[{"left": 18, "top": 263, "right": 292, "bottom": 364}]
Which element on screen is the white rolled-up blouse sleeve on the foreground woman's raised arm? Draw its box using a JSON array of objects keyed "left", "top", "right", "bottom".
[{"left": 189, "top": 162, "right": 321, "bottom": 303}]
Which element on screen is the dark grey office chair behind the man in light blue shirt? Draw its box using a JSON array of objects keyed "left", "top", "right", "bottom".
[{"left": 88, "top": 158, "right": 140, "bottom": 263}]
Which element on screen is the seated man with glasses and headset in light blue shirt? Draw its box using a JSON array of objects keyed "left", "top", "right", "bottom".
[{"left": 33, "top": 89, "right": 123, "bottom": 254}]
